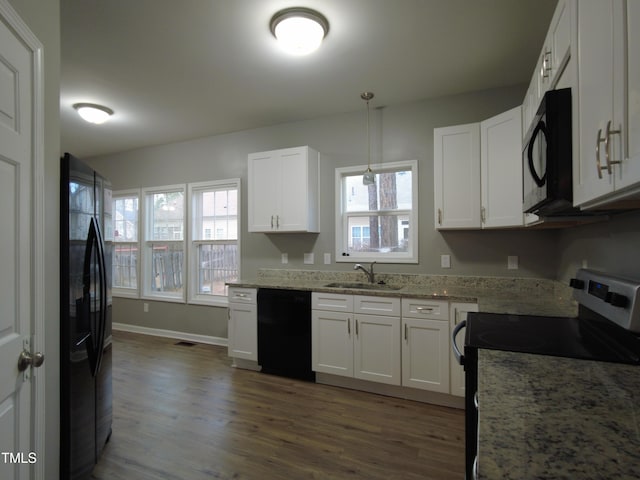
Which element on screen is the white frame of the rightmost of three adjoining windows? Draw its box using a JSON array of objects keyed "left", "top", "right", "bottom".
[{"left": 187, "top": 178, "right": 242, "bottom": 306}]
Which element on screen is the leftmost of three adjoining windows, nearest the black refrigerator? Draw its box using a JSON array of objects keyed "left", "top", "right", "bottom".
[{"left": 111, "top": 190, "right": 140, "bottom": 297}]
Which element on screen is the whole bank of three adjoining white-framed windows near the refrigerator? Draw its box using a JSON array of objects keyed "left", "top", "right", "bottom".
[{"left": 113, "top": 179, "right": 240, "bottom": 304}]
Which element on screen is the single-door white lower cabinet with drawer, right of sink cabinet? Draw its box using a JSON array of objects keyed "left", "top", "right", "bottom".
[{"left": 402, "top": 298, "right": 450, "bottom": 393}]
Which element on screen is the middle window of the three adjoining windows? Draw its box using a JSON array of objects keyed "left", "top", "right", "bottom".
[{"left": 142, "top": 185, "right": 186, "bottom": 300}]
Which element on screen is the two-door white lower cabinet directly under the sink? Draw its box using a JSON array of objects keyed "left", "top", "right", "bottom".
[{"left": 311, "top": 292, "right": 400, "bottom": 385}]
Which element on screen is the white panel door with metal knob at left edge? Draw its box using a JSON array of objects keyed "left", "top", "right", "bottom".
[{"left": 0, "top": 3, "right": 37, "bottom": 480}]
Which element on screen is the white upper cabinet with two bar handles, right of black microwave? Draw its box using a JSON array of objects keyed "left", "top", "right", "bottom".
[{"left": 573, "top": 0, "right": 640, "bottom": 208}]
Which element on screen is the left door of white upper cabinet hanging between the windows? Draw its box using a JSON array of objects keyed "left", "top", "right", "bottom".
[{"left": 247, "top": 152, "right": 281, "bottom": 232}]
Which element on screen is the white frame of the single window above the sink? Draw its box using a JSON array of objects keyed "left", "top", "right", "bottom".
[{"left": 334, "top": 160, "right": 420, "bottom": 263}]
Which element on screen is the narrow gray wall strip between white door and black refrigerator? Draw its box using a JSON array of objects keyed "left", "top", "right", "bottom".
[{"left": 9, "top": 0, "right": 60, "bottom": 478}]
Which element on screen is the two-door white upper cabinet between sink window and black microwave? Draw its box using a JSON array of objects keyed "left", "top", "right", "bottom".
[{"left": 433, "top": 107, "right": 524, "bottom": 229}]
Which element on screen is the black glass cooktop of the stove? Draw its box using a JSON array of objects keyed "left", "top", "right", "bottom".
[{"left": 465, "top": 312, "right": 640, "bottom": 365}]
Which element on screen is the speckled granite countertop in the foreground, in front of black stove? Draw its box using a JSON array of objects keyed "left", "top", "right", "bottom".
[{"left": 478, "top": 350, "right": 640, "bottom": 480}]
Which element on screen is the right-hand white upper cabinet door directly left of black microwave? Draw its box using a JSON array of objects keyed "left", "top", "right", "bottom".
[{"left": 480, "top": 107, "right": 524, "bottom": 228}]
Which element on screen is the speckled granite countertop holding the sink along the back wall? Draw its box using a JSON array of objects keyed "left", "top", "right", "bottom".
[{"left": 228, "top": 269, "right": 578, "bottom": 316}]
